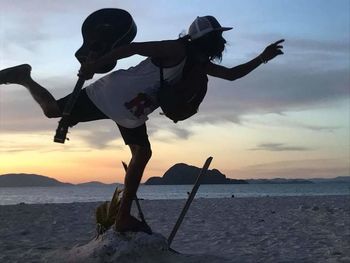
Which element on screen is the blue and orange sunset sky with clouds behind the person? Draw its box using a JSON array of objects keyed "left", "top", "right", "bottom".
[{"left": 0, "top": 0, "right": 350, "bottom": 183}]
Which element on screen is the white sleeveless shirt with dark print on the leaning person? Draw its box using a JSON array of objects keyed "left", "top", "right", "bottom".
[{"left": 86, "top": 58, "right": 186, "bottom": 128}]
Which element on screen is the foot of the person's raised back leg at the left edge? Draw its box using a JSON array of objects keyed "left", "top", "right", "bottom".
[{"left": 0, "top": 64, "right": 32, "bottom": 85}]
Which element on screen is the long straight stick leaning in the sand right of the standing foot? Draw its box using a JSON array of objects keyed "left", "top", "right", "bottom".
[{"left": 168, "top": 157, "right": 213, "bottom": 247}]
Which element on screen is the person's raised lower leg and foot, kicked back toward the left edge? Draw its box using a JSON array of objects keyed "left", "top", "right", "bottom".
[{"left": 0, "top": 64, "right": 61, "bottom": 118}]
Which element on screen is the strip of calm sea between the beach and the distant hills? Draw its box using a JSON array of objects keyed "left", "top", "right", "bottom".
[{"left": 0, "top": 183, "right": 350, "bottom": 205}]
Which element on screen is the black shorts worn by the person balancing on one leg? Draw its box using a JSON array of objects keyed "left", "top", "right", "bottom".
[{"left": 57, "top": 89, "right": 150, "bottom": 146}]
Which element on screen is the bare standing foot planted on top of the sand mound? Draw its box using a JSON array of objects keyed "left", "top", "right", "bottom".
[{"left": 114, "top": 215, "right": 152, "bottom": 235}]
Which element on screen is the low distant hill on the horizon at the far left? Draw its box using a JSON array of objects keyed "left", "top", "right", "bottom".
[{"left": 0, "top": 174, "right": 72, "bottom": 187}]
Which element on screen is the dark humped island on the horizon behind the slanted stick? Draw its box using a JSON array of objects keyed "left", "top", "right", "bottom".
[{"left": 145, "top": 163, "right": 247, "bottom": 185}]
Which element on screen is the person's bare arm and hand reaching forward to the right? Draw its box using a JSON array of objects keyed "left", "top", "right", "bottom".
[{"left": 207, "top": 39, "right": 284, "bottom": 80}]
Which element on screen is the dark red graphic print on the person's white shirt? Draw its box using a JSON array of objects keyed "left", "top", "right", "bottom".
[{"left": 124, "top": 93, "right": 154, "bottom": 118}]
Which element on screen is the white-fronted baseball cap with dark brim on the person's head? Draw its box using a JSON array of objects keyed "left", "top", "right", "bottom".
[{"left": 188, "top": 16, "right": 232, "bottom": 39}]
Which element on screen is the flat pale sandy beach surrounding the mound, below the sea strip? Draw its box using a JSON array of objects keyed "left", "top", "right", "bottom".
[{"left": 0, "top": 196, "right": 350, "bottom": 263}]
